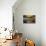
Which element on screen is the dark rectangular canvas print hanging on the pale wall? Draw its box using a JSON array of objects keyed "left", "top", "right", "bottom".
[{"left": 23, "top": 15, "right": 36, "bottom": 23}]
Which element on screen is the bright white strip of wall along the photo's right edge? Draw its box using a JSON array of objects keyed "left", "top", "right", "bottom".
[{"left": 41, "top": 0, "right": 46, "bottom": 46}]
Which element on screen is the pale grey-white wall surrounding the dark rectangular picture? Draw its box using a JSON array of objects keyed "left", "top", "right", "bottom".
[{"left": 13, "top": 0, "right": 41, "bottom": 46}]
